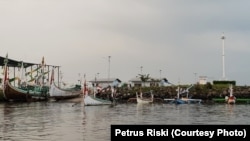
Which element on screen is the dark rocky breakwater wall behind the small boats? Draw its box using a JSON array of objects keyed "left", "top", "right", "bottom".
[{"left": 110, "top": 85, "right": 250, "bottom": 102}]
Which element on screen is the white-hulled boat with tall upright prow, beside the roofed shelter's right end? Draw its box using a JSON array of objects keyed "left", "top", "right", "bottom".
[{"left": 49, "top": 67, "right": 82, "bottom": 101}]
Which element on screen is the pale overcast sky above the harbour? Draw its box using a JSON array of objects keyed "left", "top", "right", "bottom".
[{"left": 0, "top": 0, "right": 250, "bottom": 85}]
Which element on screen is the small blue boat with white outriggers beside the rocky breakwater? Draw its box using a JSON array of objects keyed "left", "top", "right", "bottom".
[{"left": 164, "top": 85, "right": 202, "bottom": 104}]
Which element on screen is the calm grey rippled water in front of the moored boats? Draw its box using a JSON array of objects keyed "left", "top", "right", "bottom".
[{"left": 0, "top": 101, "right": 250, "bottom": 141}]
